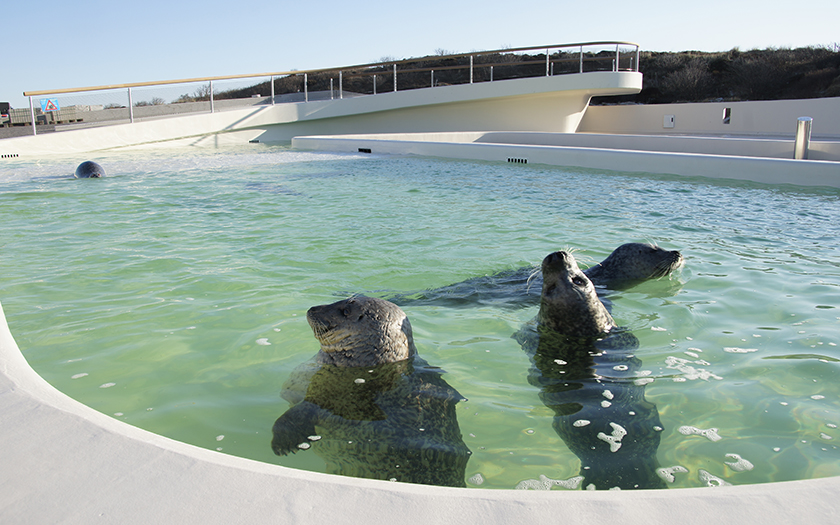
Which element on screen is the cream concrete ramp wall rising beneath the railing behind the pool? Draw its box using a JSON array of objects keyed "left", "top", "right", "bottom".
[{"left": 0, "top": 71, "right": 642, "bottom": 158}]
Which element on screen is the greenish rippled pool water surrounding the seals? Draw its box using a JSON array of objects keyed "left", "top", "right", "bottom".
[{"left": 0, "top": 146, "right": 840, "bottom": 488}]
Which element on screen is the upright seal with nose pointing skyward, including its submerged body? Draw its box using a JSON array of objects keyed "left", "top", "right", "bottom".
[{"left": 513, "top": 252, "right": 665, "bottom": 490}]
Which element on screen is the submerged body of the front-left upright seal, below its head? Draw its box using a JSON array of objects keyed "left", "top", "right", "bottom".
[{"left": 271, "top": 355, "right": 471, "bottom": 487}]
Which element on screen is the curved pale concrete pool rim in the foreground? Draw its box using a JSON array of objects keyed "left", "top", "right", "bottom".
[{"left": 0, "top": 305, "right": 840, "bottom": 524}]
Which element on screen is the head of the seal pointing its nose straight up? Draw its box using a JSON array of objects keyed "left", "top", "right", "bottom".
[{"left": 537, "top": 251, "right": 616, "bottom": 337}]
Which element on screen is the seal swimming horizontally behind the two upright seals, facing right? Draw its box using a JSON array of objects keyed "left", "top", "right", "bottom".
[{"left": 386, "top": 242, "right": 684, "bottom": 308}]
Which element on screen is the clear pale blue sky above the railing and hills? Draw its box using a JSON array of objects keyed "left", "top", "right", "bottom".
[{"left": 0, "top": 0, "right": 840, "bottom": 107}]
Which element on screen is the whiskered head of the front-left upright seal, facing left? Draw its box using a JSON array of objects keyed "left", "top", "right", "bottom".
[{"left": 306, "top": 296, "right": 417, "bottom": 366}]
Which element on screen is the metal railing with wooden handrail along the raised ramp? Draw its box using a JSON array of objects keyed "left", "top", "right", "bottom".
[{"left": 13, "top": 41, "right": 639, "bottom": 134}]
